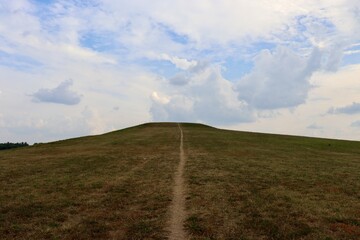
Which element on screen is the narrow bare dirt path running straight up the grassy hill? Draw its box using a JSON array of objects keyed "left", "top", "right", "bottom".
[{"left": 169, "top": 123, "right": 187, "bottom": 240}]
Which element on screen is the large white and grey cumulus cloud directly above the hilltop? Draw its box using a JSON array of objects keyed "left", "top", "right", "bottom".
[{"left": 150, "top": 66, "right": 254, "bottom": 124}]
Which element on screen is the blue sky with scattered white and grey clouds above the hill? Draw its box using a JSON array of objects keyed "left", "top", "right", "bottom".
[{"left": 0, "top": 0, "right": 360, "bottom": 143}]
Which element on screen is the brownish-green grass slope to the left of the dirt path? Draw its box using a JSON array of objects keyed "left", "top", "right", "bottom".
[{"left": 0, "top": 124, "right": 180, "bottom": 239}]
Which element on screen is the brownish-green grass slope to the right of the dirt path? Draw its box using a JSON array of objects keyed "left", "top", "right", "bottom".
[{"left": 183, "top": 125, "right": 360, "bottom": 240}]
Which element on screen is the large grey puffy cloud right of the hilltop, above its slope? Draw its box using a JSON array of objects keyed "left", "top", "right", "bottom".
[{"left": 236, "top": 47, "right": 322, "bottom": 109}]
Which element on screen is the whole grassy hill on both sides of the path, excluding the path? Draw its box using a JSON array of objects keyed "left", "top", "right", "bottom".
[{"left": 0, "top": 123, "right": 360, "bottom": 240}]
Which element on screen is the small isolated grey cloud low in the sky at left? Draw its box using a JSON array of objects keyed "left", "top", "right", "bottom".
[{"left": 32, "top": 80, "right": 81, "bottom": 105}]
